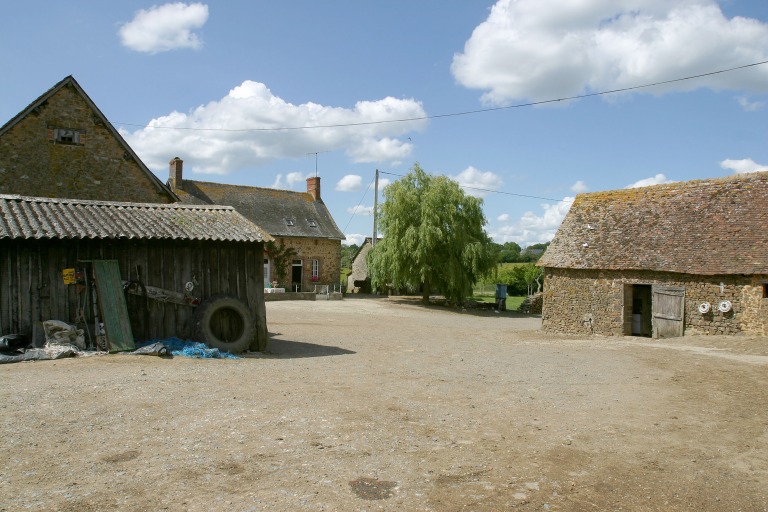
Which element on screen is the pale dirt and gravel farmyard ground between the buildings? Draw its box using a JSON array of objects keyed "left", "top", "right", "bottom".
[{"left": 0, "top": 299, "right": 768, "bottom": 511}]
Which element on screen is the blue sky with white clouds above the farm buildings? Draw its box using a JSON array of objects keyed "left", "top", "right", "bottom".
[{"left": 0, "top": 0, "right": 768, "bottom": 246}]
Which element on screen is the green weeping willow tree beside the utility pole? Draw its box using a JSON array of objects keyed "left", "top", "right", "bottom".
[{"left": 368, "top": 164, "right": 496, "bottom": 303}]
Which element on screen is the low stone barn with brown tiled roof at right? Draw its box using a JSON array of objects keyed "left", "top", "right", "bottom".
[{"left": 538, "top": 172, "right": 768, "bottom": 338}]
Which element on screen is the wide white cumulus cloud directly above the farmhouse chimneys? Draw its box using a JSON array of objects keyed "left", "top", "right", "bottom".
[{"left": 120, "top": 80, "right": 427, "bottom": 175}]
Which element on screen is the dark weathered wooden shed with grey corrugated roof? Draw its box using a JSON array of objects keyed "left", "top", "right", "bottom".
[{"left": 0, "top": 195, "right": 272, "bottom": 352}]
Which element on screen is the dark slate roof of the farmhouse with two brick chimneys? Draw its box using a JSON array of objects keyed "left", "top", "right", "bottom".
[{"left": 175, "top": 180, "right": 346, "bottom": 240}]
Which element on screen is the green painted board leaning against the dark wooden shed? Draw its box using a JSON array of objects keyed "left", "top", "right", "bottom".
[{"left": 93, "top": 260, "right": 136, "bottom": 352}]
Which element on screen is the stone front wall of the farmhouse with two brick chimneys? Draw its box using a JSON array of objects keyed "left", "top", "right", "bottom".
[{"left": 269, "top": 237, "right": 341, "bottom": 291}]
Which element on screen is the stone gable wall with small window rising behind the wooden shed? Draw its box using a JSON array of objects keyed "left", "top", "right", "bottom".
[{"left": 0, "top": 86, "right": 171, "bottom": 203}]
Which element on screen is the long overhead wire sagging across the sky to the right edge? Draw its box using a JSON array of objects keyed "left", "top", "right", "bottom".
[{"left": 113, "top": 60, "right": 768, "bottom": 132}]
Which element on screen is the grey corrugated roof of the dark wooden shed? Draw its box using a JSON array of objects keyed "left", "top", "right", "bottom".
[{"left": 0, "top": 194, "right": 272, "bottom": 242}]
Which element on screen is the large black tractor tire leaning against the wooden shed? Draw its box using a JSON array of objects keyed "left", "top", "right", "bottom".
[{"left": 195, "top": 297, "right": 256, "bottom": 354}]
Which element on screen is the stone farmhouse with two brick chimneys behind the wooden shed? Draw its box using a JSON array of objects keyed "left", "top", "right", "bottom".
[{"left": 168, "top": 157, "right": 345, "bottom": 292}]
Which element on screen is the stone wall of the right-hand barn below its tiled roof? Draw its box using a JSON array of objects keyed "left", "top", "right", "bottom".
[{"left": 542, "top": 268, "right": 768, "bottom": 336}]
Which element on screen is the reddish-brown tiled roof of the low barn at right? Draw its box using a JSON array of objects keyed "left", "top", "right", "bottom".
[{"left": 538, "top": 172, "right": 768, "bottom": 275}]
